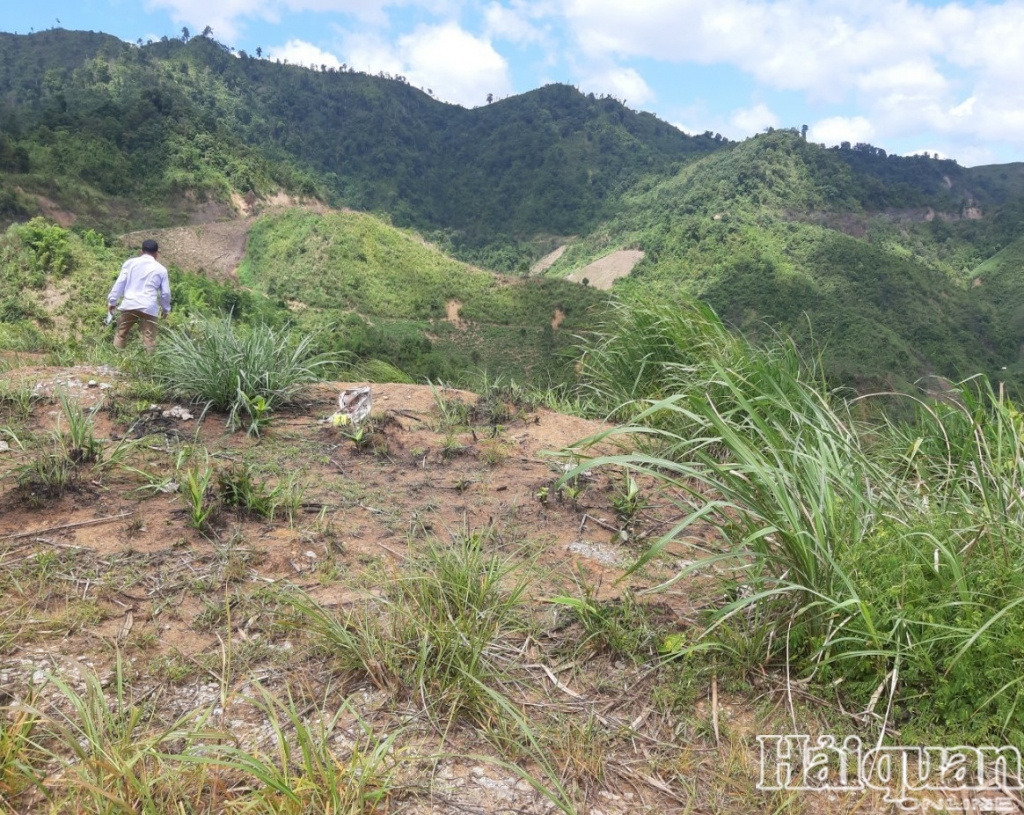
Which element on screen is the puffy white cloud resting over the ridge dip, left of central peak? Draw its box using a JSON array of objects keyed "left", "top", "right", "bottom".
[{"left": 346, "top": 23, "right": 512, "bottom": 106}]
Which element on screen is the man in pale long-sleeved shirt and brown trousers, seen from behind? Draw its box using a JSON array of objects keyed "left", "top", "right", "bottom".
[{"left": 106, "top": 241, "right": 171, "bottom": 351}]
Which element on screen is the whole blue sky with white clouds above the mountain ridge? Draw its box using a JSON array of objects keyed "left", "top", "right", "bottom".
[{"left": 8, "top": 0, "right": 1024, "bottom": 166}]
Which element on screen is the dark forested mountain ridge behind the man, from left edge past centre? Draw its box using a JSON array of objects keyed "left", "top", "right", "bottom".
[{"left": 0, "top": 30, "right": 719, "bottom": 252}]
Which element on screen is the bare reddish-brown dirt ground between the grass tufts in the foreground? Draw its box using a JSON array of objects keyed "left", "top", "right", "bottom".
[{"left": 0, "top": 359, "right": 942, "bottom": 815}]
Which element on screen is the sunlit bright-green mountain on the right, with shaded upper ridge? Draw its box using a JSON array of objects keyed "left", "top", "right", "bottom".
[{"left": 551, "top": 131, "right": 1024, "bottom": 384}]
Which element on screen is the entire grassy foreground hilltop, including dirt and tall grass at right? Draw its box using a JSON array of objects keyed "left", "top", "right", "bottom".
[{"left": 0, "top": 218, "right": 1024, "bottom": 813}]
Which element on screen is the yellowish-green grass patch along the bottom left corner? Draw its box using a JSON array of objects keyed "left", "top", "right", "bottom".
[{"left": 9, "top": 655, "right": 404, "bottom": 815}]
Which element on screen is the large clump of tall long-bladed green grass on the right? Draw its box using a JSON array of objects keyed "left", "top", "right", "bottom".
[{"left": 565, "top": 296, "right": 1024, "bottom": 744}]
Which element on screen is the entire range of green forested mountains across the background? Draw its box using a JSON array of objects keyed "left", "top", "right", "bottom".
[{"left": 6, "top": 30, "right": 1024, "bottom": 387}]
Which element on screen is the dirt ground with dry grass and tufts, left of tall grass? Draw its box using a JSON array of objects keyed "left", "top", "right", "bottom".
[{"left": 0, "top": 372, "right": 958, "bottom": 815}]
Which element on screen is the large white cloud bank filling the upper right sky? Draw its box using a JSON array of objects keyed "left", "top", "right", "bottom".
[{"left": 560, "top": 0, "right": 1024, "bottom": 152}]
